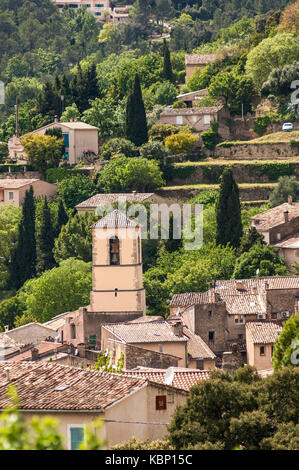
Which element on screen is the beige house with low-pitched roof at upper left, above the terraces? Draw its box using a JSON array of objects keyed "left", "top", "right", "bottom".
[{"left": 23, "top": 118, "right": 99, "bottom": 165}]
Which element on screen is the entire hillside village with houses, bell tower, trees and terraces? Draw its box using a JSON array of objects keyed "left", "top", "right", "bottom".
[{"left": 0, "top": 0, "right": 299, "bottom": 454}]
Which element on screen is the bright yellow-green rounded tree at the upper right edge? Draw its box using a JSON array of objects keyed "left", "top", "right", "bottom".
[{"left": 245, "top": 33, "right": 299, "bottom": 87}]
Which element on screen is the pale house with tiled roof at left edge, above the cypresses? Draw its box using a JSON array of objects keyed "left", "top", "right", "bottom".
[{"left": 0, "top": 177, "right": 57, "bottom": 207}]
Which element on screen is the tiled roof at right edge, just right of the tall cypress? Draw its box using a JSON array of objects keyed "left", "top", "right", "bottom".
[{"left": 250, "top": 202, "right": 299, "bottom": 231}]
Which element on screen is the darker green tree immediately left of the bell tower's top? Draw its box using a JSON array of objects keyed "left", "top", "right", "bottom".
[{"left": 53, "top": 212, "right": 98, "bottom": 263}]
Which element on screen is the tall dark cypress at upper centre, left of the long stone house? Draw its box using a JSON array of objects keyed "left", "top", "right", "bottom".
[{"left": 126, "top": 74, "right": 148, "bottom": 147}]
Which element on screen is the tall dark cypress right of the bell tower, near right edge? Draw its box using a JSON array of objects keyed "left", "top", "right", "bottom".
[{"left": 216, "top": 168, "right": 242, "bottom": 248}]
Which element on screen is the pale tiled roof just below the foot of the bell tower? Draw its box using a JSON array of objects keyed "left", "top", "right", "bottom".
[{"left": 103, "top": 321, "right": 187, "bottom": 344}]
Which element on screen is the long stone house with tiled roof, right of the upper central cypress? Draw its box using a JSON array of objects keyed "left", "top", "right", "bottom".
[{"left": 160, "top": 105, "right": 230, "bottom": 139}]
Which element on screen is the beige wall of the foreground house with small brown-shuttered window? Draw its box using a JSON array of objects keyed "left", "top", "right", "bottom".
[{"left": 19, "top": 384, "right": 186, "bottom": 449}]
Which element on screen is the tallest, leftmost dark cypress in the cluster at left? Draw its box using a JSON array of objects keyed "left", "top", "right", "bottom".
[{"left": 11, "top": 186, "right": 36, "bottom": 289}]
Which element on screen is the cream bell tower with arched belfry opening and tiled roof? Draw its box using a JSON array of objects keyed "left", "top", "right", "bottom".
[{"left": 89, "top": 210, "right": 145, "bottom": 318}]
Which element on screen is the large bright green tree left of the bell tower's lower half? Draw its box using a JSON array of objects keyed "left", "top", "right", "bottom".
[{"left": 15, "top": 258, "right": 91, "bottom": 326}]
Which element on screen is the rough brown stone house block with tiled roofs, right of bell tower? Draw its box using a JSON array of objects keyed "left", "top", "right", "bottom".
[{"left": 170, "top": 276, "right": 299, "bottom": 359}]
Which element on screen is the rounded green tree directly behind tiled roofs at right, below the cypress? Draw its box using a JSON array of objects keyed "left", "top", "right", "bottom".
[{"left": 233, "top": 243, "right": 287, "bottom": 279}]
